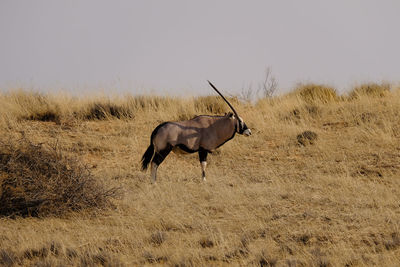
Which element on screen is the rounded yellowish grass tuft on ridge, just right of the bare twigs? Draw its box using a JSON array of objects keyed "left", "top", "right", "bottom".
[{"left": 294, "top": 83, "right": 339, "bottom": 103}]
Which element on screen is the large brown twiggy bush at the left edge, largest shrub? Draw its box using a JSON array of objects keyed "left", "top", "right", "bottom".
[{"left": 0, "top": 138, "right": 118, "bottom": 216}]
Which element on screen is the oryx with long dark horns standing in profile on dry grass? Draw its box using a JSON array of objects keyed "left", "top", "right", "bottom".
[{"left": 142, "top": 81, "right": 251, "bottom": 183}]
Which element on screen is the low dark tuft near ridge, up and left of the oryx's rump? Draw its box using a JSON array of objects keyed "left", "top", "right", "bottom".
[{"left": 84, "top": 102, "right": 134, "bottom": 120}]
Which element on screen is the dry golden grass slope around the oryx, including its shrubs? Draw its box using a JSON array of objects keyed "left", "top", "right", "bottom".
[{"left": 0, "top": 84, "right": 400, "bottom": 266}]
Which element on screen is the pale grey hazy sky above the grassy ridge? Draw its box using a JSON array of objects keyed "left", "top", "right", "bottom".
[{"left": 0, "top": 0, "right": 400, "bottom": 95}]
